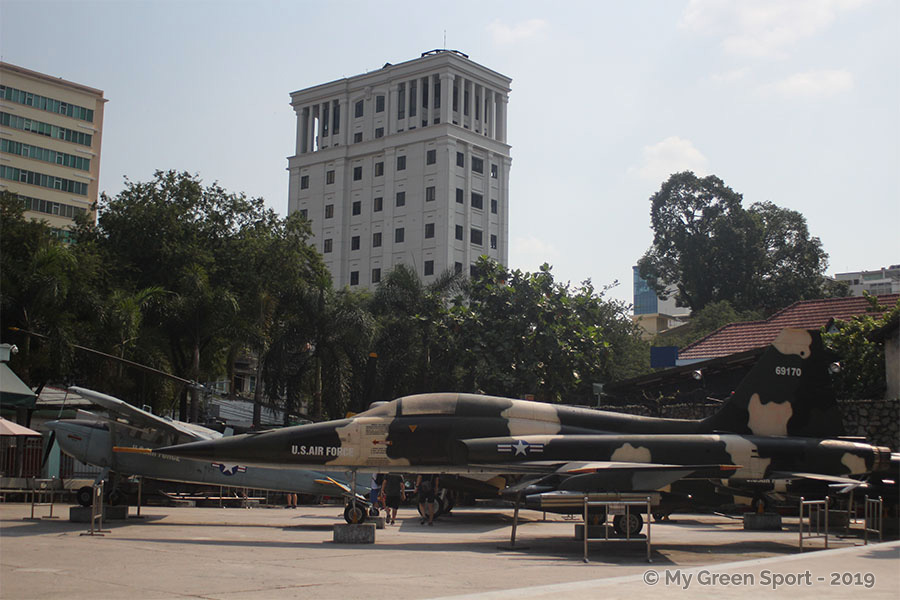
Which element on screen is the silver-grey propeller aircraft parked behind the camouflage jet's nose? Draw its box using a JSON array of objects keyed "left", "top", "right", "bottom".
[{"left": 47, "top": 387, "right": 369, "bottom": 520}]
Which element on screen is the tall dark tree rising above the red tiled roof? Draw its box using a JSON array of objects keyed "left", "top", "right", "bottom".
[{"left": 638, "top": 171, "right": 828, "bottom": 313}]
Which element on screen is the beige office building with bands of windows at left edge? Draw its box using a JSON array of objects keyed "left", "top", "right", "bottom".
[{"left": 0, "top": 62, "right": 106, "bottom": 236}]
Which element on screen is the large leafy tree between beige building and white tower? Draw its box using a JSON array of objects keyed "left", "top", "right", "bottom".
[{"left": 94, "top": 171, "right": 298, "bottom": 420}]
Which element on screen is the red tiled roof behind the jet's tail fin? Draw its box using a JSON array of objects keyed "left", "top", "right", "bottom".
[{"left": 678, "top": 294, "right": 900, "bottom": 360}]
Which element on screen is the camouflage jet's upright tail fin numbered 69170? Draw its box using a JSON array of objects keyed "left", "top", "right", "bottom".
[{"left": 702, "top": 328, "right": 844, "bottom": 438}]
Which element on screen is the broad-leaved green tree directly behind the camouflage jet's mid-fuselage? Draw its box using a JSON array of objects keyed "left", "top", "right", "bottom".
[{"left": 448, "top": 257, "right": 648, "bottom": 403}]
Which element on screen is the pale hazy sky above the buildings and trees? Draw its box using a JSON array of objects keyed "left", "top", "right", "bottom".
[{"left": 0, "top": 0, "right": 900, "bottom": 302}]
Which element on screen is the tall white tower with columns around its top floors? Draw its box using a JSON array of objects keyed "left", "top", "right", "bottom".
[{"left": 288, "top": 50, "right": 511, "bottom": 289}]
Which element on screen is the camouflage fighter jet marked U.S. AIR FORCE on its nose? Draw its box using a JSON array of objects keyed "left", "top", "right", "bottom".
[{"left": 155, "top": 329, "right": 891, "bottom": 530}]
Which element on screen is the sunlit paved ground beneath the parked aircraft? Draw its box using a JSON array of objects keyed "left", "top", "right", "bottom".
[{"left": 0, "top": 504, "right": 900, "bottom": 600}]
